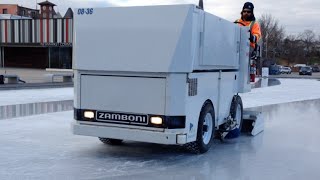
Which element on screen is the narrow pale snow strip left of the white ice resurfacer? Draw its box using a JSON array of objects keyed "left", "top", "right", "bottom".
[{"left": 0, "top": 88, "right": 73, "bottom": 106}]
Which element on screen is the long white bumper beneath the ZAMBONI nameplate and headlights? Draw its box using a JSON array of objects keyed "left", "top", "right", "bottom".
[{"left": 72, "top": 121, "right": 187, "bottom": 144}]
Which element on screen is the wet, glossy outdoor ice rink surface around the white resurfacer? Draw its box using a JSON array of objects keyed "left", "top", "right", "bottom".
[{"left": 0, "top": 80, "right": 320, "bottom": 180}]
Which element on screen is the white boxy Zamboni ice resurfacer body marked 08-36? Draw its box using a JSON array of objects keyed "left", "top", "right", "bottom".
[{"left": 73, "top": 5, "right": 262, "bottom": 153}]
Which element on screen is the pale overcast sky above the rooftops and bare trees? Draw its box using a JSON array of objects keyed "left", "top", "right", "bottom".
[{"left": 0, "top": 0, "right": 320, "bottom": 35}]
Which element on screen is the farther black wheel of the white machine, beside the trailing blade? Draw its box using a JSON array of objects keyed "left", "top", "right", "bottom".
[{"left": 230, "top": 95, "right": 243, "bottom": 130}]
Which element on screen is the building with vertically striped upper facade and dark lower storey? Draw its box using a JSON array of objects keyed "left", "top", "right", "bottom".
[{"left": 0, "top": 1, "right": 73, "bottom": 69}]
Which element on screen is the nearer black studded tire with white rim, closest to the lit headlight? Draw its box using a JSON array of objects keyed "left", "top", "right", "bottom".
[{"left": 185, "top": 101, "right": 215, "bottom": 154}]
